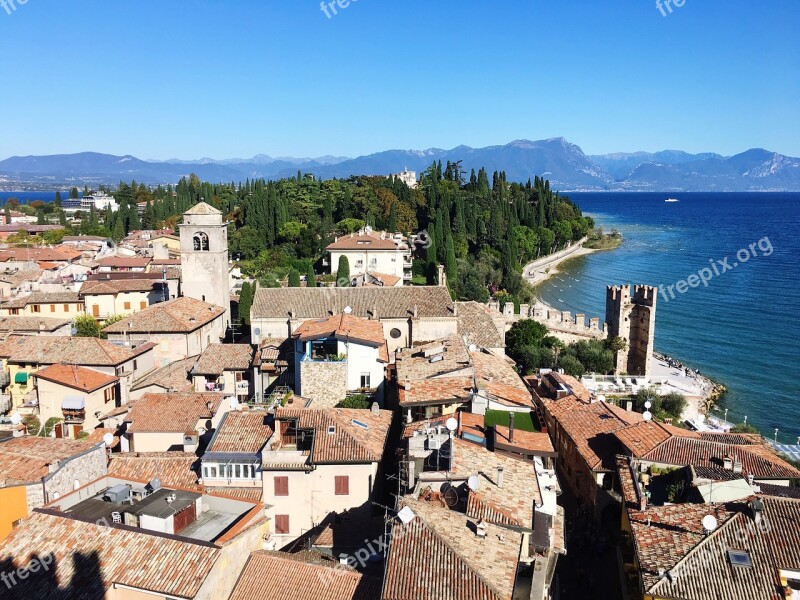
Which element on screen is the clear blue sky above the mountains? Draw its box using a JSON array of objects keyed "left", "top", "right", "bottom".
[{"left": 0, "top": 0, "right": 800, "bottom": 159}]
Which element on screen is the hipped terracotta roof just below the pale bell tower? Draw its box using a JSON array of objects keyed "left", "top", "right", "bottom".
[{"left": 103, "top": 297, "right": 225, "bottom": 333}]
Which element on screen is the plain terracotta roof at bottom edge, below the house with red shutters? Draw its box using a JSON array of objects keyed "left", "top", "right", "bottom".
[{"left": 230, "top": 550, "right": 381, "bottom": 600}]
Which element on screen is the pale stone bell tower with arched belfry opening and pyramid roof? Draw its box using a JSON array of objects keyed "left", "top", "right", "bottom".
[{"left": 180, "top": 202, "right": 231, "bottom": 327}]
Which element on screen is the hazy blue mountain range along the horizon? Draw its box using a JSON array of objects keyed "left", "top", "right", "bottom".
[{"left": 0, "top": 138, "right": 800, "bottom": 192}]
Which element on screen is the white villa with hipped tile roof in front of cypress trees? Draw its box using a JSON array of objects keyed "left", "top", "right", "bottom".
[{"left": 326, "top": 227, "right": 413, "bottom": 285}]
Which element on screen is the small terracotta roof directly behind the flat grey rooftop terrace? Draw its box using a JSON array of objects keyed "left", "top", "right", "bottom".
[{"left": 108, "top": 452, "right": 198, "bottom": 489}]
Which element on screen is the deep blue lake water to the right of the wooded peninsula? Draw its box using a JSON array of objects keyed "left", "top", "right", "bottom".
[{"left": 538, "top": 193, "right": 800, "bottom": 443}]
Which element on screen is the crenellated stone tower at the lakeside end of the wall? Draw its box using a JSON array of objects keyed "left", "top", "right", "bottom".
[{"left": 606, "top": 285, "right": 658, "bottom": 376}]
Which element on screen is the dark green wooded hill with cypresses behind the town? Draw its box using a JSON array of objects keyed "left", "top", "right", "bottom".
[{"left": 26, "top": 162, "right": 594, "bottom": 302}]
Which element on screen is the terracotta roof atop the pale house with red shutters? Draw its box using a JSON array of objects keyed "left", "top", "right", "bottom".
[{"left": 272, "top": 408, "right": 392, "bottom": 464}]
